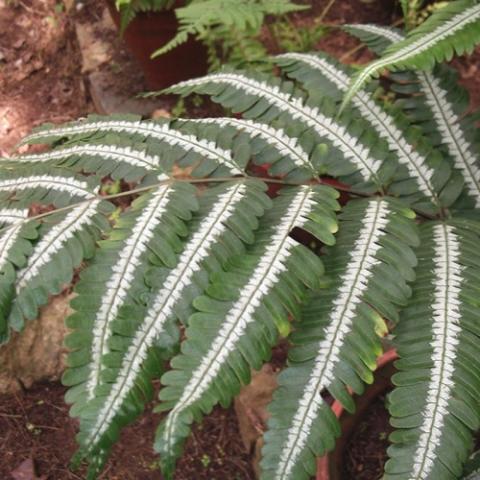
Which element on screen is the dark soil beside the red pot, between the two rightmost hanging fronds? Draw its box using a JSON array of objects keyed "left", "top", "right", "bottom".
[{"left": 342, "top": 395, "right": 393, "bottom": 480}]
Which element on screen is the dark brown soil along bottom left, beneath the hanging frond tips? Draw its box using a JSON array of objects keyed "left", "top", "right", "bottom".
[{"left": 0, "top": 383, "right": 254, "bottom": 480}]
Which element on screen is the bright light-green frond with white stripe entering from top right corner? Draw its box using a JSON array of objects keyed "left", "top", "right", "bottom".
[{"left": 343, "top": 0, "right": 480, "bottom": 109}]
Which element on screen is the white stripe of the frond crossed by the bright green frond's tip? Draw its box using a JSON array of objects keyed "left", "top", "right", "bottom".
[{"left": 279, "top": 53, "right": 438, "bottom": 203}]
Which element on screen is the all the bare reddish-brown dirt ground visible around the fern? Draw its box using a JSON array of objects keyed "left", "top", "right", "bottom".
[{"left": 0, "top": 0, "right": 480, "bottom": 480}]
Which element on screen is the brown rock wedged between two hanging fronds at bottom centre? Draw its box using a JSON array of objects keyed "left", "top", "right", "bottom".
[{"left": 235, "top": 363, "right": 277, "bottom": 478}]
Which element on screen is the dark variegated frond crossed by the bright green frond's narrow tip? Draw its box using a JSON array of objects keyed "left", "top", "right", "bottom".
[{"left": 276, "top": 53, "right": 448, "bottom": 209}]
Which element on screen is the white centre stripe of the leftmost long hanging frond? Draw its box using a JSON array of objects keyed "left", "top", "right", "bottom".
[{"left": 87, "top": 185, "right": 171, "bottom": 399}]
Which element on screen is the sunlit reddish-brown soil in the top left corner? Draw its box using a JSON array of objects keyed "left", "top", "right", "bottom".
[{"left": 0, "top": 0, "right": 92, "bottom": 155}]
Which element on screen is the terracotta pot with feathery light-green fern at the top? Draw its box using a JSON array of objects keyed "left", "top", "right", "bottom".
[{"left": 107, "top": 0, "right": 308, "bottom": 89}]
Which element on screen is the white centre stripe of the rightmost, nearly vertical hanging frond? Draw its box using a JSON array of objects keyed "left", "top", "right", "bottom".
[{"left": 409, "top": 224, "right": 463, "bottom": 480}]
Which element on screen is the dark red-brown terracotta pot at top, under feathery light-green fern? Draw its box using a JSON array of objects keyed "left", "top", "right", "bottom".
[{"left": 107, "top": 0, "right": 207, "bottom": 90}]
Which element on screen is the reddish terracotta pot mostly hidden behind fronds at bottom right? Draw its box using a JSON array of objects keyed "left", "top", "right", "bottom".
[{"left": 316, "top": 349, "right": 398, "bottom": 480}]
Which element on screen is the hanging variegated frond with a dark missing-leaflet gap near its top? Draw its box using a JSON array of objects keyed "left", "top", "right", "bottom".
[{"left": 156, "top": 186, "right": 337, "bottom": 478}]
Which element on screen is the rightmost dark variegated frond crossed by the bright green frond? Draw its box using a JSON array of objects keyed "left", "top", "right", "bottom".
[{"left": 346, "top": 25, "right": 480, "bottom": 208}]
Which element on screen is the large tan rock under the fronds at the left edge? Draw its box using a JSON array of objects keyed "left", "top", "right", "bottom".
[{"left": 0, "top": 293, "right": 73, "bottom": 393}]
